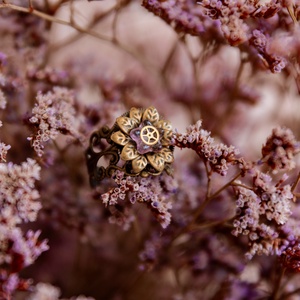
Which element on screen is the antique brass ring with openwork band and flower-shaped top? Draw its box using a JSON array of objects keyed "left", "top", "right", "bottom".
[{"left": 86, "top": 106, "right": 174, "bottom": 186}]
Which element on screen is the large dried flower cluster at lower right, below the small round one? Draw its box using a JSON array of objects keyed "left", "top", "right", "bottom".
[{"left": 232, "top": 172, "right": 293, "bottom": 259}]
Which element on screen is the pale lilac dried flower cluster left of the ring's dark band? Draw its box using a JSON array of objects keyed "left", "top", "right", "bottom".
[{"left": 28, "top": 87, "right": 81, "bottom": 156}]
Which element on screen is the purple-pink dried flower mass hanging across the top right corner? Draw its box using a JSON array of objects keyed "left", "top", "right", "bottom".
[{"left": 143, "top": 0, "right": 299, "bottom": 73}]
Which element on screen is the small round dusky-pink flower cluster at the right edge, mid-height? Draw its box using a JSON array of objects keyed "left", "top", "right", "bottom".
[{"left": 262, "top": 127, "right": 300, "bottom": 173}]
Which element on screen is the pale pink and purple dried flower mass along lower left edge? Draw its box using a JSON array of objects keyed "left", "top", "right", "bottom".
[{"left": 0, "top": 159, "right": 49, "bottom": 299}]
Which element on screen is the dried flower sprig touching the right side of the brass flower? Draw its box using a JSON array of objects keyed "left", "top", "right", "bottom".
[{"left": 173, "top": 121, "right": 239, "bottom": 176}]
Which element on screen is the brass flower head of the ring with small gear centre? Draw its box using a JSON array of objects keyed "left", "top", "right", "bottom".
[{"left": 110, "top": 106, "right": 174, "bottom": 177}]
